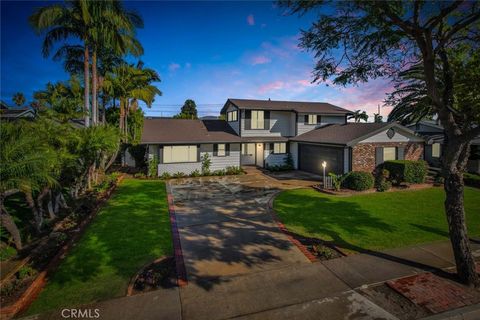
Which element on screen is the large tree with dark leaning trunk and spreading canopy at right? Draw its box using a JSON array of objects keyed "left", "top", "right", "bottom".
[{"left": 283, "top": 1, "right": 480, "bottom": 286}]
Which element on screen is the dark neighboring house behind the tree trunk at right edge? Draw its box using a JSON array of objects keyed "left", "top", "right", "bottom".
[{"left": 407, "top": 120, "right": 480, "bottom": 173}]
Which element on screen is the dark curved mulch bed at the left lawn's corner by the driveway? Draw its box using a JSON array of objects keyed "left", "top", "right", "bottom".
[{"left": 127, "top": 257, "right": 177, "bottom": 296}]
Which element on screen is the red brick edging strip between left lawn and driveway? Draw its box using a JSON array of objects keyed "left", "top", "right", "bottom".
[{"left": 166, "top": 181, "right": 188, "bottom": 287}]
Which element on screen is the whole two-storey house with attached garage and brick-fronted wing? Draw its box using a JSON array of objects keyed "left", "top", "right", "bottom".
[{"left": 141, "top": 99, "right": 424, "bottom": 174}]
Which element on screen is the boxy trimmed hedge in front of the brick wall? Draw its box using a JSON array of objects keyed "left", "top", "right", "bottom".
[{"left": 383, "top": 160, "right": 428, "bottom": 184}]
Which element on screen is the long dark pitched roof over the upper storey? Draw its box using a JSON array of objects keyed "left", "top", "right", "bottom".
[{"left": 221, "top": 98, "right": 352, "bottom": 115}]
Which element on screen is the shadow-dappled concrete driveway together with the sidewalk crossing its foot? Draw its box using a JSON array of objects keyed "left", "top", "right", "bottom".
[{"left": 28, "top": 174, "right": 480, "bottom": 320}]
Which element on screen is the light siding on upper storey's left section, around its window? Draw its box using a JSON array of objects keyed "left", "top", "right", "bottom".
[{"left": 241, "top": 110, "right": 295, "bottom": 137}]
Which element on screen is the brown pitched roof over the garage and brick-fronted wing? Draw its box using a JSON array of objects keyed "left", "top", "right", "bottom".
[{"left": 291, "top": 122, "right": 414, "bottom": 145}]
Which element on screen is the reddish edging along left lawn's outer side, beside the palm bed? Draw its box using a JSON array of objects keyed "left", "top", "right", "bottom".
[{"left": 0, "top": 175, "right": 124, "bottom": 319}]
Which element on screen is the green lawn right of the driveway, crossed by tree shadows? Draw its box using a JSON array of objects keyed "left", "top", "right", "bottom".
[{"left": 274, "top": 188, "right": 480, "bottom": 251}]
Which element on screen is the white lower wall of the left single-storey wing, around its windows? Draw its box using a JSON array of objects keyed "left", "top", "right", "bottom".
[{"left": 157, "top": 143, "right": 240, "bottom": 175}]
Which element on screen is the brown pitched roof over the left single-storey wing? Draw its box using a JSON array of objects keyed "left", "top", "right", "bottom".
[{"left": 141, "top": 118, "right": 240, "bottom": 144}]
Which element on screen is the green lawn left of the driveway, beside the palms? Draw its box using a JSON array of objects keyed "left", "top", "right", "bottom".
[{"left": 27, "top": 179, "right": 172, "bottom": 314}]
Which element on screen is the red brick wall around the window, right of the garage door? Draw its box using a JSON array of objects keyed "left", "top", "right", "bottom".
[{"left": 352, "top": 142, "right": 423, "bottom": 172}]
